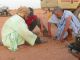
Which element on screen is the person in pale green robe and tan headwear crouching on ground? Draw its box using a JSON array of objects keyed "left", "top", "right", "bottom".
[{"left": 1, "top": 7, "right": 41, "bottom": 51}]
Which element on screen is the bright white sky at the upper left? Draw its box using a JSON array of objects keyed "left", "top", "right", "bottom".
[{"left": 0, "top": 0, "right": 41, "bottom": 9}]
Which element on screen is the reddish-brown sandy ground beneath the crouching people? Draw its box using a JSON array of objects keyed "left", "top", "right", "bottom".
[{"left": 0, "top": 17, "right": 77, "bottom": 60}]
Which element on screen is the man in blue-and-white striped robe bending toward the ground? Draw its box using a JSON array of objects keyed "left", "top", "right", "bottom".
[{"left": 54, "top": 7, "right": 80, "bottom": 41}]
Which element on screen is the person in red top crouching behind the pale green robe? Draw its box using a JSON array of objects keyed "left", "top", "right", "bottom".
[{"left": 25, "top": 8, "right": 40, "bottom": 31}]
